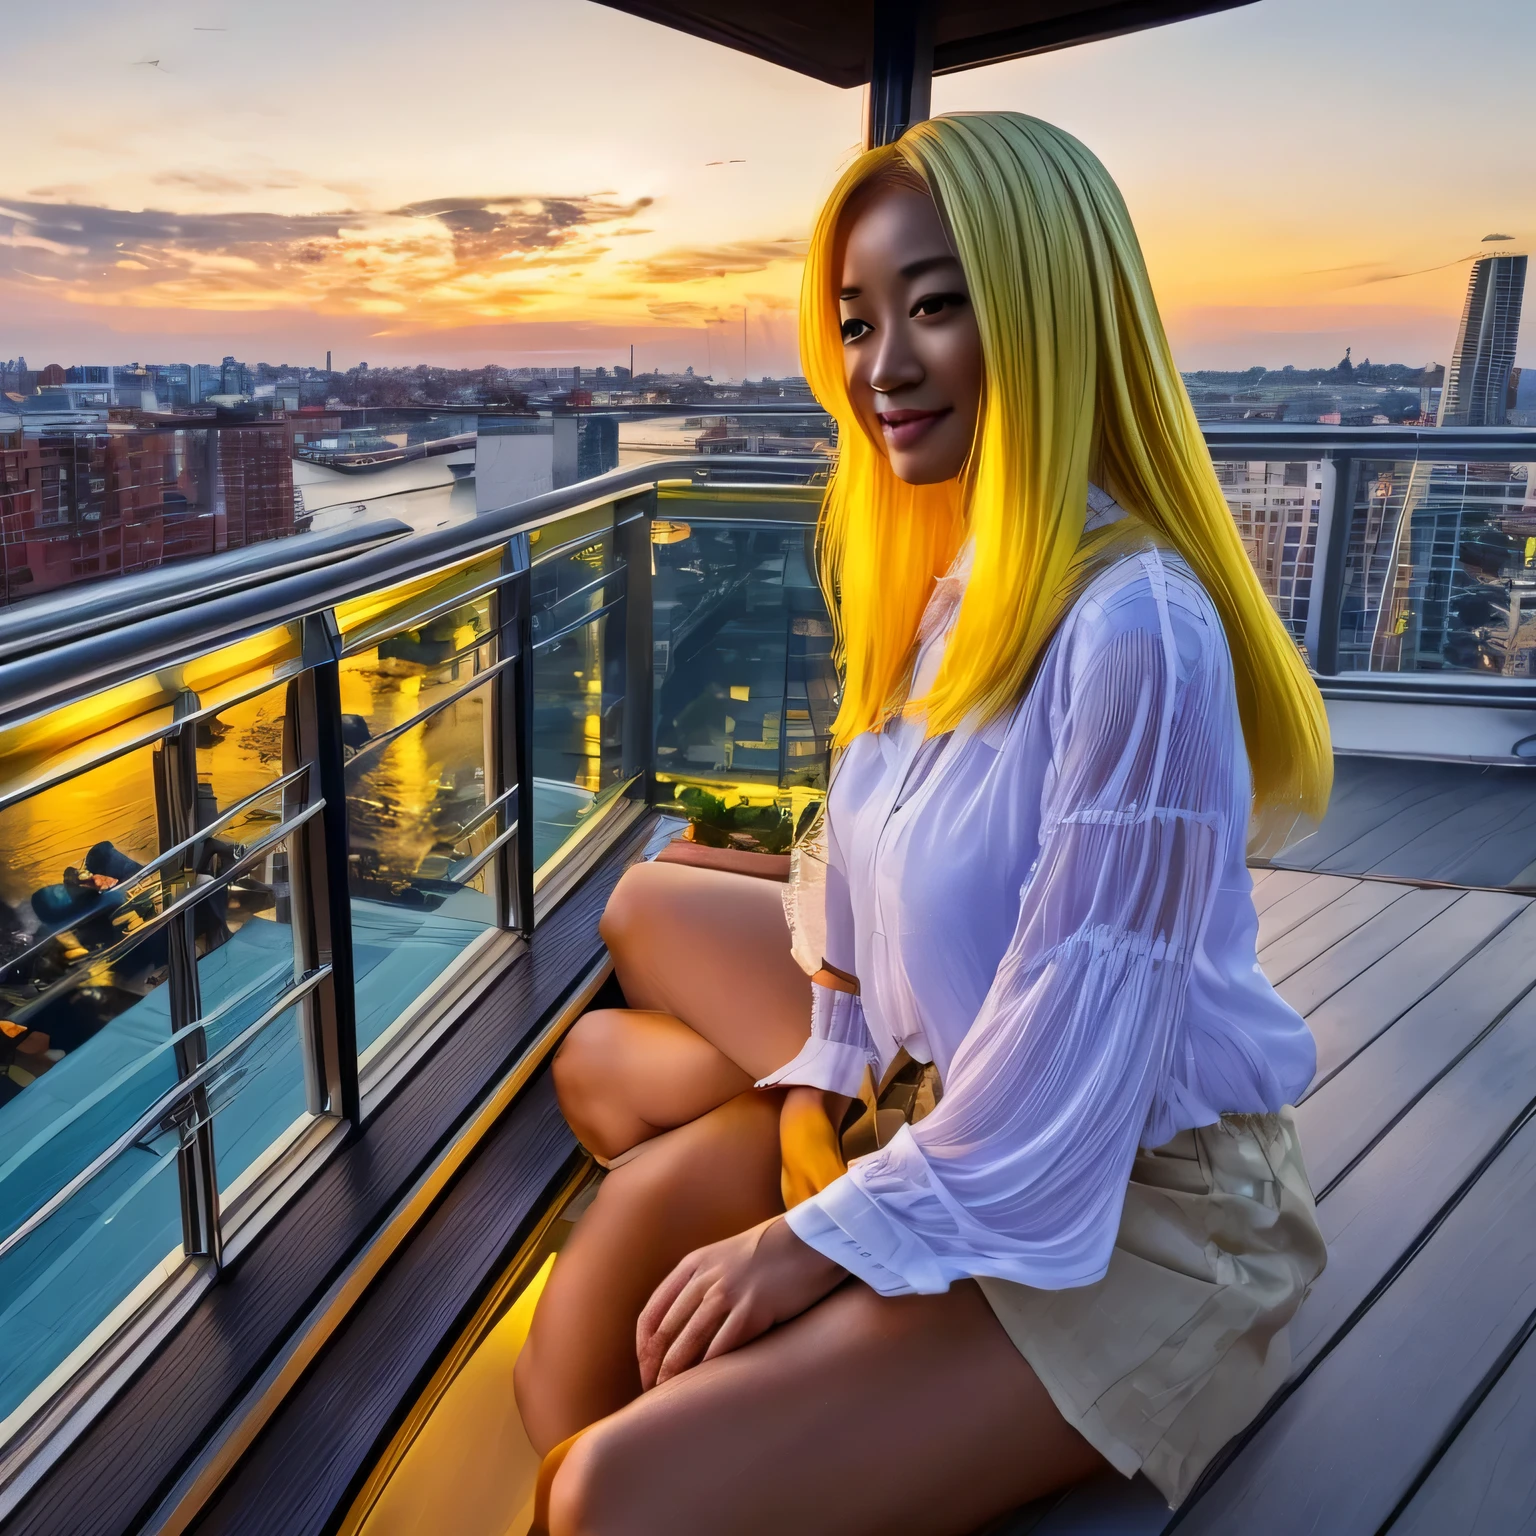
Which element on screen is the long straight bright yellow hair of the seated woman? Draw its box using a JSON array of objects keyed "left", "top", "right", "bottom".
[{"left": 800, "top": 112, "right": 1333, "bottom": 845}]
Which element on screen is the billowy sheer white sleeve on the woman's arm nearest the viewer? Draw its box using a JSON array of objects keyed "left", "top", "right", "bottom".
[{"left": 788, "top": 564, "right": 1249, "bottom": 1295}]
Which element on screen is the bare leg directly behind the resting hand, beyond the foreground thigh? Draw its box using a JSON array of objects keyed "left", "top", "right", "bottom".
[{"left": 515, "top": 1089, "right": 783, "bottom": 1455}]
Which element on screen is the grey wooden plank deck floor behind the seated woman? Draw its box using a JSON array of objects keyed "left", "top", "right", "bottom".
[{"left": 994, "top": 872, "right": 1536, "bottom": 1536}]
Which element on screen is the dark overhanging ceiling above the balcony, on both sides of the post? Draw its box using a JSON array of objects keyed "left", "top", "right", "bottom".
[{"left": 592, "top": 0, "right": 1252, "bottom": 86}]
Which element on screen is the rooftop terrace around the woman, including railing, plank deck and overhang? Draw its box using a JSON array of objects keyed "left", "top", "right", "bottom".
[{"left": 9, "top": 0, "right": 1536, "bottom": 1536}]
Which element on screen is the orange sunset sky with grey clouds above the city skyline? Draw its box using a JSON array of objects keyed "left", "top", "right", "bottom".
[{"left": 0, "top": 0, "right": 1536, "bottom": 376}]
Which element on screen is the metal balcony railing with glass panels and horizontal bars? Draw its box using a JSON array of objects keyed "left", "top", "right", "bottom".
[{"left": 9, "top": 427, "right": 1536, "bottom": 1513}]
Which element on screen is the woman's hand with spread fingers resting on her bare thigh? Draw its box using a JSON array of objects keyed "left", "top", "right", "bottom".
[{"left": 634, "top": 1217, "right": 848, "bottom": 1392}]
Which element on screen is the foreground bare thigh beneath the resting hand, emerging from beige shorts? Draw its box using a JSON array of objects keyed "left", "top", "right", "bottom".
[{"left": 550, "top": 1281, "right": 1104, "bottom": 1536}]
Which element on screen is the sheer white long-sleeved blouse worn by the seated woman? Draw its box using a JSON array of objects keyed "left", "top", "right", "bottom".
[{"left": 762, "top": 531, "right": 1316, "bottom": 1295}]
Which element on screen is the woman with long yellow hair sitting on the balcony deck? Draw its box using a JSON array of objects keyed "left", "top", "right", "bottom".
[{"left": 518, "top": 114, "right": 1330, "bottom": 1536}]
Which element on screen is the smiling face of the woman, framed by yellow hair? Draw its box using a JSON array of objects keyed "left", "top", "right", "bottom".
[{"left": 840, "top": 187, "right": 982, "bottom": 485}]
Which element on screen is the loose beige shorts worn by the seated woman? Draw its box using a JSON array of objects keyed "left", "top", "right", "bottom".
[{"left": 978, "top": 1109, "right": 1327, "bottom": 1508}]
